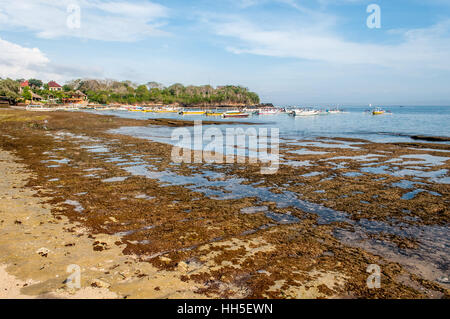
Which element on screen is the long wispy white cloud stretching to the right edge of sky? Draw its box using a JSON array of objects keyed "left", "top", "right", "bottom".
[{"left": 214, "top": 20, "right": 450, "bottom": 70}]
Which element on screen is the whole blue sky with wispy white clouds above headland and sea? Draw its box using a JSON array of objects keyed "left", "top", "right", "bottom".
[{"left": 0, "top": 0, "right": 450, "bottom": 105}]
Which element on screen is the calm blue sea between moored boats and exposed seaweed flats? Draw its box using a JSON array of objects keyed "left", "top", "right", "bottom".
[{"left": 97, "top": 106, "right": 450, "bottom": 143}]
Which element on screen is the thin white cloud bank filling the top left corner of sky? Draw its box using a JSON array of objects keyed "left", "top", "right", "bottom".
[{"left": 0, "top": 0, "right": 168, "bottom": 42}]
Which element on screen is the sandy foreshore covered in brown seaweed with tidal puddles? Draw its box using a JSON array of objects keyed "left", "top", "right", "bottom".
[{"left": 0, "top": 110, "right": 449, "bottom": 298}]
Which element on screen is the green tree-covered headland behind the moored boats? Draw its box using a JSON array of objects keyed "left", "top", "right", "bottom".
[{"left": 0, "top": 79, "right": 259, "bottom": 106}]
